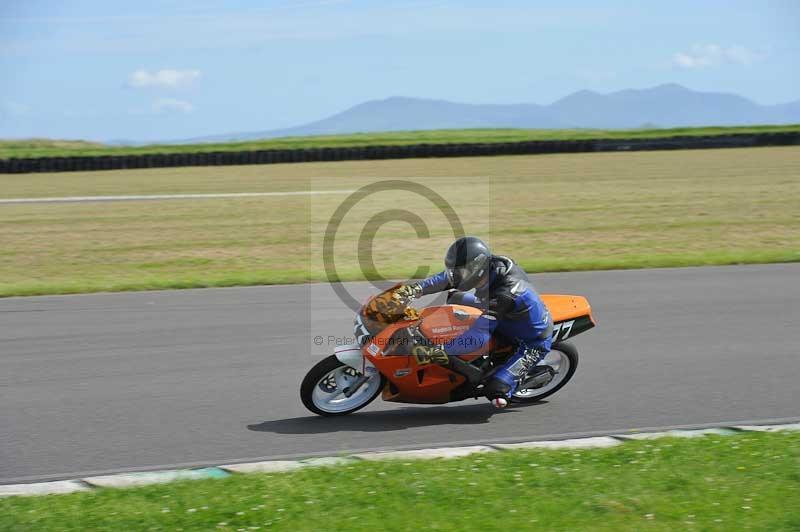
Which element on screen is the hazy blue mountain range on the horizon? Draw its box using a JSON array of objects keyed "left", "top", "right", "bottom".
[{"left": 185, "top": 84, "right": 800, "bottom": 142}]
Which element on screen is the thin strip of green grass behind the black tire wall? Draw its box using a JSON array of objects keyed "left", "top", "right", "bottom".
[{"left": 0, "top": 125, "right": 800, "bottom": 159}]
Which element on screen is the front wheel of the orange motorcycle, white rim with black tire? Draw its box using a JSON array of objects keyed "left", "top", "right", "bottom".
[{"left": 300, "top": 355, "right": 384, "bottom": 416}]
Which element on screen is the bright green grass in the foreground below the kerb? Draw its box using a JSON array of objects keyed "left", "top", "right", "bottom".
[{"left": 0, "top": 433, "right": 800, "bottom": 531}]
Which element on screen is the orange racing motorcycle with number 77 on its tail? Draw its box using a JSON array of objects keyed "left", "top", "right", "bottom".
[{"left": 300, "top": 284, "right": 595, "bottom": 416}]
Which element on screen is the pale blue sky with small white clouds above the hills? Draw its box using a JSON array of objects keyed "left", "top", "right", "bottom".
[{"left": 0, "top": 0, "right": 800, "bottom": 140}]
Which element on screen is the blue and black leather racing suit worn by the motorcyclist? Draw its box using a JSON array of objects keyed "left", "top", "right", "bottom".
[{"left": 420, "top": 255, "right": 553, "bottom": 395}]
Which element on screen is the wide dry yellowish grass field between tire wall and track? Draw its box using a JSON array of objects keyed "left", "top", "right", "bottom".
[{"left": 0, "top": 147, "right": 800, "bottom": 296}]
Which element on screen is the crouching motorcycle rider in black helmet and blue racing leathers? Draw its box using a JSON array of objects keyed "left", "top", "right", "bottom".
[{"left": 397, "top": 236, "right": 553, "bottom": 408}]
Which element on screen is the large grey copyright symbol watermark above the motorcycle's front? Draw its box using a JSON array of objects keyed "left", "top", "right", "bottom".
[{"left": 322, "top": 179, "right": 464, "bottom": 312}]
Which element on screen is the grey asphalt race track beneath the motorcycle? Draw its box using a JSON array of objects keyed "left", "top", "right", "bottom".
[{"left": 0, "top": 264, "right": 800, "bottom": 483}]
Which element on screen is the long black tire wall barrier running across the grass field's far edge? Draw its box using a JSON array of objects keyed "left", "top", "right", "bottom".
[{"left": 0, "top": 131, "right": 800, "bottom": 174}]
